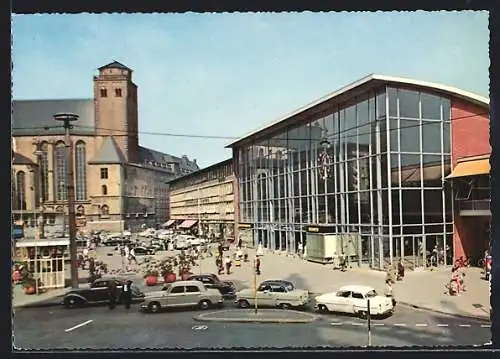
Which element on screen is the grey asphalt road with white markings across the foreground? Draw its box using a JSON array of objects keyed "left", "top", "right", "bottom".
[{"left": 14, "top": 306, "right": 490, "bottom": 349}]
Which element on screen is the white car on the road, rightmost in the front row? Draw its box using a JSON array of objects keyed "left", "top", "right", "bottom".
[{"left": 315, "top": 285, "right": 394, "bottom": 317}]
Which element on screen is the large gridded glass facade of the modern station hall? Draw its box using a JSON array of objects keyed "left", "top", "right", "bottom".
[{"left": 236, "top": 87, "right": 453, "bottom": 268}]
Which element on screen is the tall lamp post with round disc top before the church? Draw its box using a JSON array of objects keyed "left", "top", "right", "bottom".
[{"left": 53, "top": 113, "right": 78, "bottom": 289}]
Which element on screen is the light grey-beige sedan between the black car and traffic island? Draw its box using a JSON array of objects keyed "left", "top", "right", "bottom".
[{"left": 140, "top": 280, "right": 223, "bottom": 313}]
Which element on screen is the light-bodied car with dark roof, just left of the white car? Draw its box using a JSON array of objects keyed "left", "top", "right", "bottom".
[{"left": 235, "top": 281, "right": 309, "bottom": 309}]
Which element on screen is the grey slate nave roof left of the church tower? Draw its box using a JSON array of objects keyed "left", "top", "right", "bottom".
[{"left": 11, "top": 99, "right": 95, "bottom": 136}]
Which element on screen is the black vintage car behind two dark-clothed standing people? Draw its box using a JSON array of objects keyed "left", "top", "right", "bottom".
[{"left": 62, "top": 277, "right": 145, "bottom": 308}]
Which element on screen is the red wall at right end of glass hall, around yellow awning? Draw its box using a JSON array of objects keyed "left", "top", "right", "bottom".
[{"left": 451, "top": 99, "right": 491, "bottom": 258}]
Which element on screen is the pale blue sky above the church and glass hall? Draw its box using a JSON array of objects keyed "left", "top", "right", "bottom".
[{"left": 12, "top": 11, "right": 489, "bottom": 166}]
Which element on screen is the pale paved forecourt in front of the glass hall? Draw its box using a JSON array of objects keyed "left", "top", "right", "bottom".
[{"left": 197, "top": 248, "right": 490, "bottom": 319}]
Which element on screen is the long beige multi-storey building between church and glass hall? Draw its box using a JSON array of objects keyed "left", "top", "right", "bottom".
[{"left": 167, "top": 159, "right": 235, "bottom": 239}]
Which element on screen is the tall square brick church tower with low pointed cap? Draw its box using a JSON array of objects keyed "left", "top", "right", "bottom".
[{"left": 94, "top": 61, "right": 139, "bottom": 162}]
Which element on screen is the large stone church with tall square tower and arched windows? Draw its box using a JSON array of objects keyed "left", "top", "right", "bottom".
[{"left": 12, "top": 62, "right": 198, "bottom": 231}]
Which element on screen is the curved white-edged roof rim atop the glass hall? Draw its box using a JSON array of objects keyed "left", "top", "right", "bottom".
[{"left": 226, "top": 74, "right": 490, "bottom": 148}]
